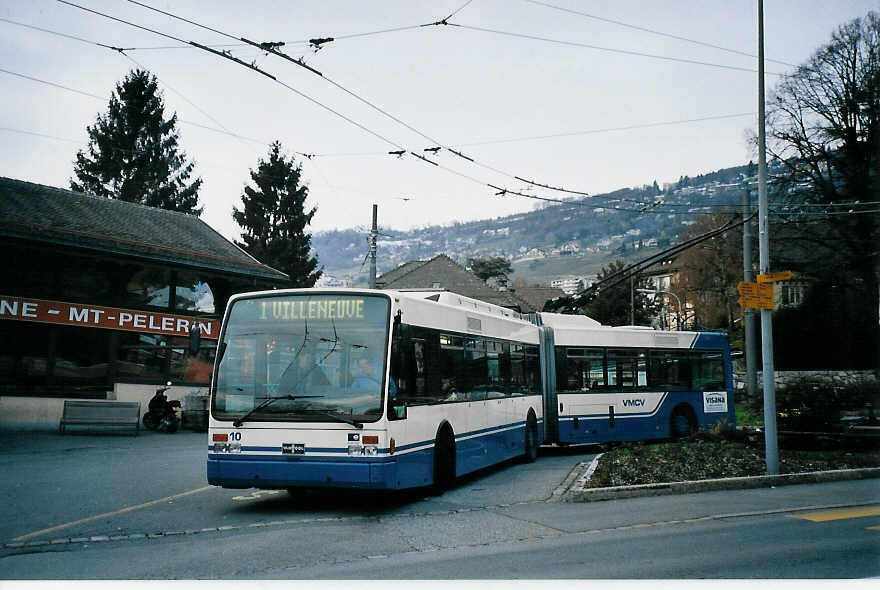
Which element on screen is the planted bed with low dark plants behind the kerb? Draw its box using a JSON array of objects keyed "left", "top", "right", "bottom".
[{"left": 588, "top": 437, "right": 880, "bottom": 488}]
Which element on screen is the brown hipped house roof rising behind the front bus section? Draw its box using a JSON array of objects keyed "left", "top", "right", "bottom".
[{"left": 376, "top": 254, "right": 535, "bottom": 313}]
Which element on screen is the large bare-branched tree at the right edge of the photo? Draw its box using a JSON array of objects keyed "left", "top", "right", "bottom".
[{"left": 768, "top": 12, "right": 880, "bottom": 368}]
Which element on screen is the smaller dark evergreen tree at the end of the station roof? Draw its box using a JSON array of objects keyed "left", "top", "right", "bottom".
[{"left": 232, "top": 141, "right": 323, "bottom": 287}]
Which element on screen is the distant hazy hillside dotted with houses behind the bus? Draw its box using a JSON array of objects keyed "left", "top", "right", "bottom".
[{"left": 312, "top": 166, "right": 753, "bottom": 291}]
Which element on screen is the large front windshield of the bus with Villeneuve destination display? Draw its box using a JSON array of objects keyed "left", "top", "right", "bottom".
[{"left": 211, "top": 293, "right": 390, "bottom": 422}]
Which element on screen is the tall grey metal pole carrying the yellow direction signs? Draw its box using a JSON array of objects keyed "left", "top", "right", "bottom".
[{"left": 758, "top": 0, "right": 779, "bottom": 475}]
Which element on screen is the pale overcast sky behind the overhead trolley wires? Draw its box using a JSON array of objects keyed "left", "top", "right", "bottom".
[{"left": 0, "top": 0, "right": 878, "bottom": 238}]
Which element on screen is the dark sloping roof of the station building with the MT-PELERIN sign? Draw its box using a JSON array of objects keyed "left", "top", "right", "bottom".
[{"left": 0, "top": 177, "right": 288, "bottom": 281}]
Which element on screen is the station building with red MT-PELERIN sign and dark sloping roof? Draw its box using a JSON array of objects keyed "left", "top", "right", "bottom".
[{"left": 0, "top": 177, "right": 288, "bottom": 430}]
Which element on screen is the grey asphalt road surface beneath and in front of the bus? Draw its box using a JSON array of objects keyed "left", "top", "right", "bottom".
[{"left": 0, "top": 432, "right": 880, "bottom": 580}]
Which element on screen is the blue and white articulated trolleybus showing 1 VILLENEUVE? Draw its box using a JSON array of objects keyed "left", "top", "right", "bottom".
[{"left": 207, "top": 289, "right": 734, "bottom": 489}]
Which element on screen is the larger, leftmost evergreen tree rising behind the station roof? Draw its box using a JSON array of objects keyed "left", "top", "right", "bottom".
[{"left": 70, "top": 69, "right": 202, "bottom": 215}]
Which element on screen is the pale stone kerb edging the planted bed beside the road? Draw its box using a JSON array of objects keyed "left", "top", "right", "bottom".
[{"left": 557, "top": 463, "right": 880, "bottom": 502}]
